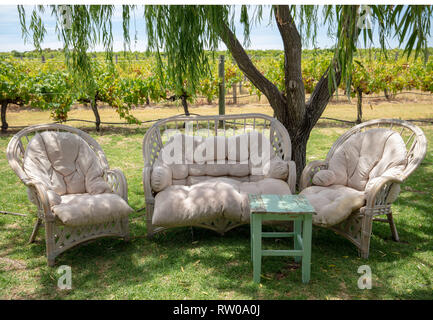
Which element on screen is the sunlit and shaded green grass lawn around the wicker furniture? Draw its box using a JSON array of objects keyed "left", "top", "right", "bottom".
[{"left": 0, "top": 105, "right": 433, "bottom": 299}]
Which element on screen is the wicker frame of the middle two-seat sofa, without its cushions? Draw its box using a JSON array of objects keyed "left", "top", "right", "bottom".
[{"left": 143, "top": 113, "right": 296, "bottom": 236}]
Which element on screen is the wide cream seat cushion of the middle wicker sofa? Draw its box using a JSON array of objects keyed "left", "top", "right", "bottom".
[{"left": 152, "top": 177, "right": 290, "bottom": 227}]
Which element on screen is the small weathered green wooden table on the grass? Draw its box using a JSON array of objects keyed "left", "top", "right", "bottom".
[{"left": 249, "top": 194, "right": 316, "bottom": 283}]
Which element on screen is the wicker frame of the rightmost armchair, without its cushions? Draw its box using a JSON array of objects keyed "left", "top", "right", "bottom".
[{"left": 300, "top": 119, "right": 427, "bottom": 258}]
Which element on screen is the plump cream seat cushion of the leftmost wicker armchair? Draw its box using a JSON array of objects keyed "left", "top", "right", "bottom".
[{"left": 51, "top": 193, "right": 134, "bottom": 227}]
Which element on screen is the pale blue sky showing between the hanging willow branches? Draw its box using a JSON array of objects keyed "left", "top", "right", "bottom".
[{"left": 0, "top": 5, "right": 433, "bottom": 52}]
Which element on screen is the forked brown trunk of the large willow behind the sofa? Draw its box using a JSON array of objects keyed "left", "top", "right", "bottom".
[{"left": 220, "top": 6, "right": 341, "bottom": 188}]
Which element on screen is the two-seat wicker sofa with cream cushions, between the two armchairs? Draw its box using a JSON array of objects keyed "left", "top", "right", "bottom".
[{"left": 143, "top": 114, "right": 296, "bottom": 236}]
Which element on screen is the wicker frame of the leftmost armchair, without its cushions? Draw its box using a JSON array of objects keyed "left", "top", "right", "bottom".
[{"left": 6, "top": 124, "right": 129, "bottom": 266}]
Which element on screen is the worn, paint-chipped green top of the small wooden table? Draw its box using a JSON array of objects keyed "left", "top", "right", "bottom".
[{"left": 248, "top": 194, "right": 316, "bottom": 214}]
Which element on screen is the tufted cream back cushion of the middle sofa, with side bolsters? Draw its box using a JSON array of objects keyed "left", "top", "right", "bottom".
[{"left": 151, "top": 131, "right": 289, "bottom": 192}]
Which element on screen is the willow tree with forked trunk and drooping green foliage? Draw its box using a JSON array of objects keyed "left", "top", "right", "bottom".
[{"left": 18, "top": 5, "right": 433, "bottom": 182}]
